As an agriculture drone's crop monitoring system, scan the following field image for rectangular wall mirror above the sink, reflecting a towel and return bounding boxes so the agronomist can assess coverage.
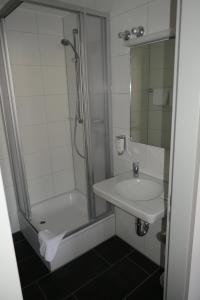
[130,39,175,149]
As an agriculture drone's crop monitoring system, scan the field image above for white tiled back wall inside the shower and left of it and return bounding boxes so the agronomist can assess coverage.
[0,9,79,231]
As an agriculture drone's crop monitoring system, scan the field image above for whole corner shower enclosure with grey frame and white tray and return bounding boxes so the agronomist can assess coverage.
[0,0,114,270]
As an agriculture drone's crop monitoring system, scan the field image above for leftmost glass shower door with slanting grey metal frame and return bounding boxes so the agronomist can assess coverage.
[0,20,31,219]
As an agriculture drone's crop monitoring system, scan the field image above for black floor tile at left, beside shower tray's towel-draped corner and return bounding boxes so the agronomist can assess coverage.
[18,255,49,287]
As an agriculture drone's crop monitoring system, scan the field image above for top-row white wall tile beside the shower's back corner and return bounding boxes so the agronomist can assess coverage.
[37,13,63,36]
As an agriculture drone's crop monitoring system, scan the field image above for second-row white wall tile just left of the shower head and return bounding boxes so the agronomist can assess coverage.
[39,35,65,66]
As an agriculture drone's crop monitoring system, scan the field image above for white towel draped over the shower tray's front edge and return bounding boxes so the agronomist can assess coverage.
[38,229,65,262]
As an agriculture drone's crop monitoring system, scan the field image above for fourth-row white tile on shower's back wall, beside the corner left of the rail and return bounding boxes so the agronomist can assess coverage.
[45,95,69,122]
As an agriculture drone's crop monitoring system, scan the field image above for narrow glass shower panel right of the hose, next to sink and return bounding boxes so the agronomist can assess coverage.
[86,15,109,216]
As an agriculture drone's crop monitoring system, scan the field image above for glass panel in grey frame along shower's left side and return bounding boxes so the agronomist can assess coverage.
[0,21,30,218]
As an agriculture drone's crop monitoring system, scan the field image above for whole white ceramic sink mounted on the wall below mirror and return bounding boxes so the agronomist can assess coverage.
[93,172,165,223]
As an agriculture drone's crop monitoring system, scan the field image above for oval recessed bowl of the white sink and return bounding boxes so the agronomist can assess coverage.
[115,178,163,201]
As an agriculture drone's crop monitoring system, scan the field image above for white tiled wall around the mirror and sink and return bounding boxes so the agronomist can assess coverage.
[111,0,174,263]
